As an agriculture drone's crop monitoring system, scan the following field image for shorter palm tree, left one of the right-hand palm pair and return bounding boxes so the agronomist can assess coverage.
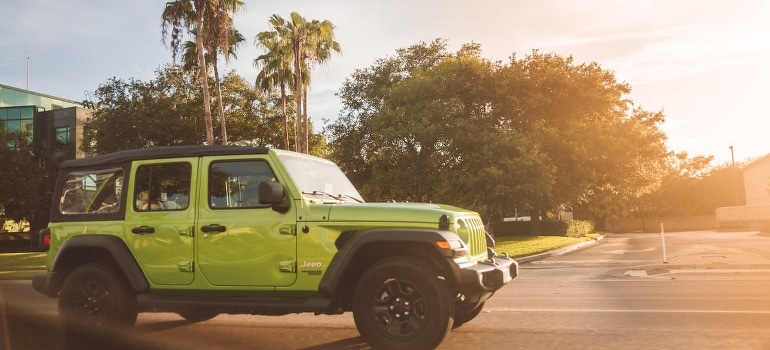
[254,23,297,149]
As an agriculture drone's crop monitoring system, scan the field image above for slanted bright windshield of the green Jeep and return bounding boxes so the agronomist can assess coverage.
[279,154,363,202]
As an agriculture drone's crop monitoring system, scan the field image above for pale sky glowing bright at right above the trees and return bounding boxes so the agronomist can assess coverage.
[0,0,770,165]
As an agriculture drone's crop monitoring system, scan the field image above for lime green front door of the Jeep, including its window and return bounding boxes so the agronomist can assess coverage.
[196,156,297,288]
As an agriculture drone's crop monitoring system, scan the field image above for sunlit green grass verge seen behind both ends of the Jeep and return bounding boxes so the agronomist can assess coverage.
[0,233,601,280]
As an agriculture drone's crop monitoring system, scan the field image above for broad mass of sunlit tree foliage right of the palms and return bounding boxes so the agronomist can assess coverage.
[326,40,666,224]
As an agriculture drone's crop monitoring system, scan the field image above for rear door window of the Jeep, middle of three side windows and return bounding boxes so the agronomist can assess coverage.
[133,163,192,211]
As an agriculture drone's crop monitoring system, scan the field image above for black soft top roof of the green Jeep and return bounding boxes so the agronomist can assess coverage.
[59,145,269,169]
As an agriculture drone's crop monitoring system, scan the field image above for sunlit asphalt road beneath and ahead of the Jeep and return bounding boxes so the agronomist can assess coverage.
[0,232,770,350]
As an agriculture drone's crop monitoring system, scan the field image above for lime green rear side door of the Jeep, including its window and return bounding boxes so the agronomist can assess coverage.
[124,157,198,285]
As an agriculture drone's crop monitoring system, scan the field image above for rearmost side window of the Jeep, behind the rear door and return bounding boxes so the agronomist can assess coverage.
[59,169,123,214]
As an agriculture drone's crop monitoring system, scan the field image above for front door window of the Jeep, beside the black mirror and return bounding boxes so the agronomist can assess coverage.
[208,160,275,209]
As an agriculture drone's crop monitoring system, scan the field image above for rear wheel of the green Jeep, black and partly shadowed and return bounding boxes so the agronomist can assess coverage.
[59,263,137,329]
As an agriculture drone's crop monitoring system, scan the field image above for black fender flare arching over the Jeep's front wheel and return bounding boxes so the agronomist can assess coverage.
[318,228,468,294]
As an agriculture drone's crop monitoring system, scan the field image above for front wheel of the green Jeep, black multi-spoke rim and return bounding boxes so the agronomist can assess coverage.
[352,257,455,349]
